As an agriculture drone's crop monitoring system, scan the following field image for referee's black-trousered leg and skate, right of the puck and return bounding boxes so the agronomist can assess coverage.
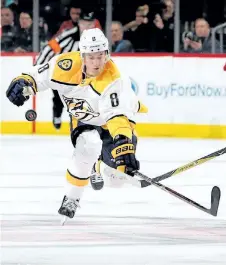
[53,90,64,129]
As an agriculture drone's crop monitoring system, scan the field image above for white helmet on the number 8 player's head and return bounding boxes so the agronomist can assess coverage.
[79,28,109,54]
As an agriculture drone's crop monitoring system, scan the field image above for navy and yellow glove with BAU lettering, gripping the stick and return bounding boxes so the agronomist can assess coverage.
[111,135,140,175]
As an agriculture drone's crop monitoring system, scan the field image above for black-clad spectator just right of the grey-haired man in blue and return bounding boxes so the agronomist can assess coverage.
[124,7,150,52]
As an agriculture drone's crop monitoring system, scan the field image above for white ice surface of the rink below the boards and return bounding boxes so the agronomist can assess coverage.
[0,136,226,265]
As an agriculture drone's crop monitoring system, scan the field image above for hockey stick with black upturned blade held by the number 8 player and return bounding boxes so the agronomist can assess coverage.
[135,172,221,216]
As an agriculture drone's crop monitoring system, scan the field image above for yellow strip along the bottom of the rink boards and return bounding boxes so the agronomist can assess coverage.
[0,121,226,139]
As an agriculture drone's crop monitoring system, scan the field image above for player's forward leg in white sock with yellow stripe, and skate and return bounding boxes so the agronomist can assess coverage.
[58,122,102,218]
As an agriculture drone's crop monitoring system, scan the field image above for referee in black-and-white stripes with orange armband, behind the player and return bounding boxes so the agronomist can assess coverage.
[35,12,98,130]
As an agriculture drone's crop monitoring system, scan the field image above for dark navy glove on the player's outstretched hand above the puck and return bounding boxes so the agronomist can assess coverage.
[6,78,32,107]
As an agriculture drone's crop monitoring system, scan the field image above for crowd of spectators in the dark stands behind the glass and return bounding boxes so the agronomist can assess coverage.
[1,0,220,53]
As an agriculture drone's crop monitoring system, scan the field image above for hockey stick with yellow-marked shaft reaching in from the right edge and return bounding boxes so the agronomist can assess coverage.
[141,144,226,188]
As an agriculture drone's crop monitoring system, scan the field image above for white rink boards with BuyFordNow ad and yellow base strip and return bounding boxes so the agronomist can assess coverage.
[0,54,226,139]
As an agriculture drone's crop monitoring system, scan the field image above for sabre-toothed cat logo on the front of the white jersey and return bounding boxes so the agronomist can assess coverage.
[63,96,100,121]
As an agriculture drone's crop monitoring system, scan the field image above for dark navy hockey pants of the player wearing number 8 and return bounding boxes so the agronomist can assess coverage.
[71,122,137,168]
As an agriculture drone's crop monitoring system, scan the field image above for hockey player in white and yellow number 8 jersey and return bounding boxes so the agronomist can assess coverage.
[6,29,147,221]
